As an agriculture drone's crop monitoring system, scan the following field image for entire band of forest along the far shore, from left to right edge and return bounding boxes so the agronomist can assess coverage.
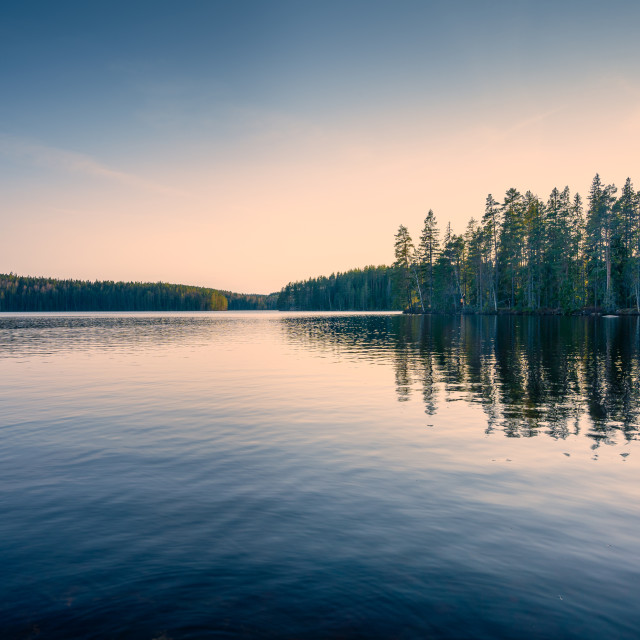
[5,174,640,314]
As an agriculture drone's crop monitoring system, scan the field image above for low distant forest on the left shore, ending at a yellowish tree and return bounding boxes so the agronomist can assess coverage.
[0,273,229,311]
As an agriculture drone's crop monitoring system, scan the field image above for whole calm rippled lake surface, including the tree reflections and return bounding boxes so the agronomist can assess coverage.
[0,312,640,640]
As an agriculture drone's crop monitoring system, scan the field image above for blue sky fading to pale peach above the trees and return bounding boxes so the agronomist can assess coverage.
[0,0,640,293]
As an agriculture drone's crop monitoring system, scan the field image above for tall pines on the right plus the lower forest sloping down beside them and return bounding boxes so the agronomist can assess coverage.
[278,175,640,314]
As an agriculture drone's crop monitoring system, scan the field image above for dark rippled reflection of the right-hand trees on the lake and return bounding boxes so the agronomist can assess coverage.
[285,315,640,448]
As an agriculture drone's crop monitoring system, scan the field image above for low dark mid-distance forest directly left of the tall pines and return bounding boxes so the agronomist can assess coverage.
[277,266,401,311]
